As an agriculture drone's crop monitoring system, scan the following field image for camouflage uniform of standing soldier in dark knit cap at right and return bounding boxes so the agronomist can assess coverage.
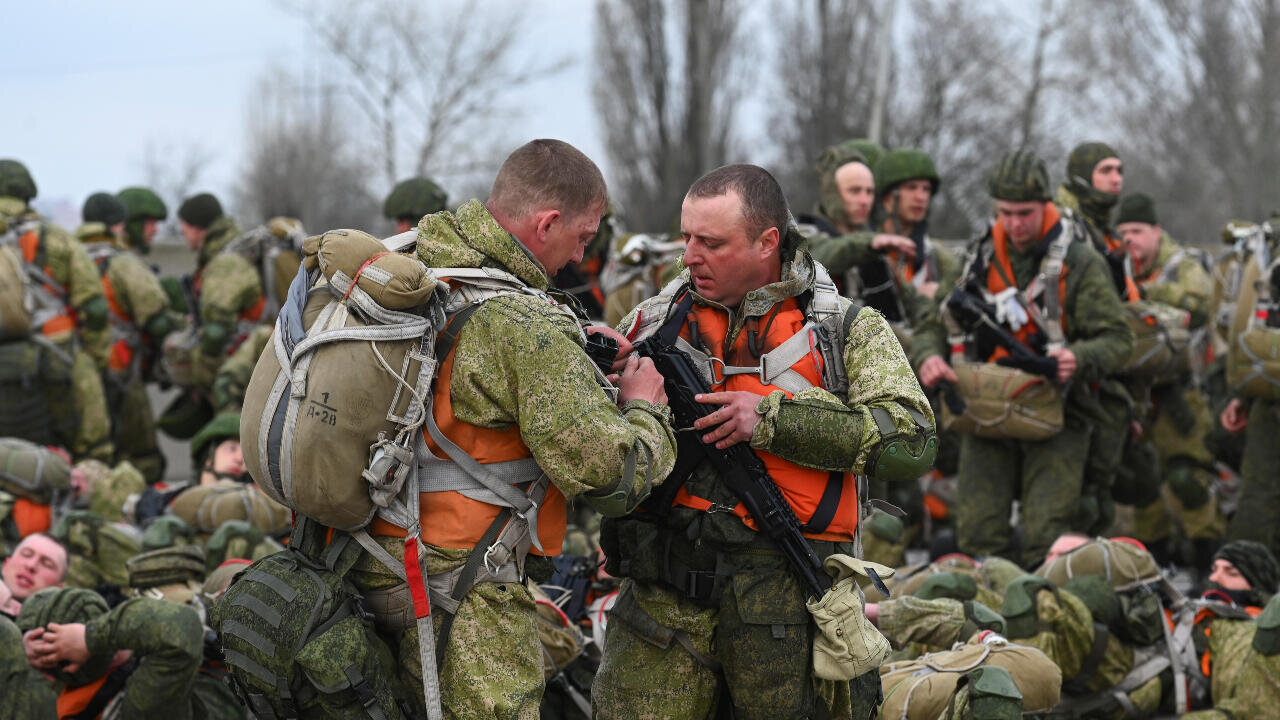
[1125,233,1226,550]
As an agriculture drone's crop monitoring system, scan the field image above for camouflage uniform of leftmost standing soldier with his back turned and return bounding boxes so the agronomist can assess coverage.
[0,192,114,461]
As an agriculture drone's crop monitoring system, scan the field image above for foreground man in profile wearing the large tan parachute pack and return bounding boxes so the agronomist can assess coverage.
[352,140,675,719]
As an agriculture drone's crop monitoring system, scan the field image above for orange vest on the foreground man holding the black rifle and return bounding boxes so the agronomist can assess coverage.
[673,292,858,542]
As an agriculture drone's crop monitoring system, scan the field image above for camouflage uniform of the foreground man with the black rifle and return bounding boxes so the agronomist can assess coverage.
[591,245,933,719]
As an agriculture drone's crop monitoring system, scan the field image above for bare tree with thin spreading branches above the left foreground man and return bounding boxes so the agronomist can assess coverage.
[293,0,567,188]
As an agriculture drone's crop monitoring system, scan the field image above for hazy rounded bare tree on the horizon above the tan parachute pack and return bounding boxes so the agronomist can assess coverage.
[236,70,381,232]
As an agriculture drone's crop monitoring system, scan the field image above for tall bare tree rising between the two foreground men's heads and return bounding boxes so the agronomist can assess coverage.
[593,0,744,229]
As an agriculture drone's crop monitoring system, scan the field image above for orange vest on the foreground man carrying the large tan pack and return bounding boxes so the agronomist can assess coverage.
[369,299,567,557]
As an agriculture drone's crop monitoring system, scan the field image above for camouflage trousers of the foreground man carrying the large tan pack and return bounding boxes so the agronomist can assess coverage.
[351,538,544,720]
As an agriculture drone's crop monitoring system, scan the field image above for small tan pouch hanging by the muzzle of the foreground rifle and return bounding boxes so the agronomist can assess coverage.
[806,555,893,682]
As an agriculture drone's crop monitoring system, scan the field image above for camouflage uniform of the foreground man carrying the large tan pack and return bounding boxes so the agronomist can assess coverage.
[351,200,675,720]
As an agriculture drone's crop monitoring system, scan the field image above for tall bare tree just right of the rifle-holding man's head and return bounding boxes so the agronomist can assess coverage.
[771,0,883,210]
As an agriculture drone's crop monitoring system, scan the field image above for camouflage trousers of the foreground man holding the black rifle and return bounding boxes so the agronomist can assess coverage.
[591,565,878,720]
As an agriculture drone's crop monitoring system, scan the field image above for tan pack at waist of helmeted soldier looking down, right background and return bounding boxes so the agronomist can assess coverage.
[942,363,1064,441]
